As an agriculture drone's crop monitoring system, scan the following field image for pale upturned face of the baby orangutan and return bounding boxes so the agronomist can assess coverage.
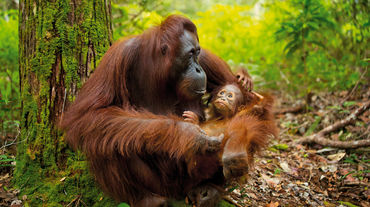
[212,85,243,118]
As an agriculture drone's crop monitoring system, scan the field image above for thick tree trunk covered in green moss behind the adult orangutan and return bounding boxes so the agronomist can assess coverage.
[13,0,112,206]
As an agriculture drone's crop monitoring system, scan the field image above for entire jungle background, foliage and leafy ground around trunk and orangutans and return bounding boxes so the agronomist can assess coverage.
[0,0,370,206]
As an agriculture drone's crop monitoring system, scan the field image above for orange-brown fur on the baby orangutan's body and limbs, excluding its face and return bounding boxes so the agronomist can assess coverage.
[201,90,278,178]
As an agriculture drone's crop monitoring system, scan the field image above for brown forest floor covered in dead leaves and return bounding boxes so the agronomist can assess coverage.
[0,87,370,207]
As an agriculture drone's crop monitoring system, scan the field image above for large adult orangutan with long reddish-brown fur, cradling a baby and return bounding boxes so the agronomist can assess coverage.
[62,15,274,206]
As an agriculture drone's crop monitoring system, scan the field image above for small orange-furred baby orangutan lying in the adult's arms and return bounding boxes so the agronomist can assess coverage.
[183,84,277,207]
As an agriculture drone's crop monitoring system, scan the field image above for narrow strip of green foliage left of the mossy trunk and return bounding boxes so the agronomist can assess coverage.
[0,10,20,135]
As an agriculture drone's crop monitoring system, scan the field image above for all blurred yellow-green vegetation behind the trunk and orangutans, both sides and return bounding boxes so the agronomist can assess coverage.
[0,0,370,136]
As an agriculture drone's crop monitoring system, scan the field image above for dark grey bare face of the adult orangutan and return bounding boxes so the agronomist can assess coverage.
[174,30,207,100]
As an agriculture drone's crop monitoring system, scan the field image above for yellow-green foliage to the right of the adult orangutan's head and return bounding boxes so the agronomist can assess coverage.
[191,0,370,94]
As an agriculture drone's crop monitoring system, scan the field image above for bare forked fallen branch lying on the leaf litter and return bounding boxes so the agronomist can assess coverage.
[295,101,370,149]
